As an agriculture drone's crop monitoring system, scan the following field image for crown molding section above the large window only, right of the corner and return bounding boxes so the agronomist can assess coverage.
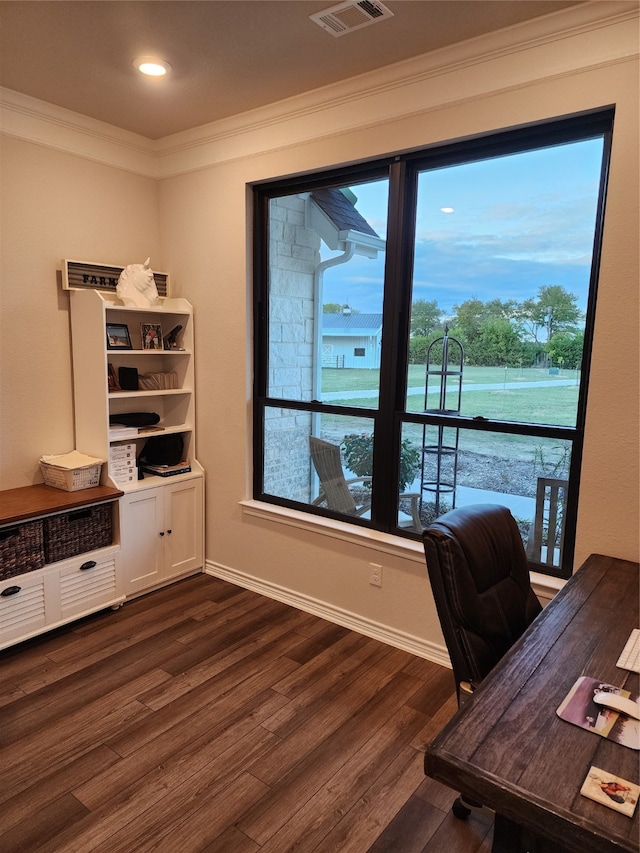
[159,0,639,177]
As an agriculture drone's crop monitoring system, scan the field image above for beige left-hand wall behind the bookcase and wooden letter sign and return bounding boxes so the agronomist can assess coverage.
[0,135,162,489]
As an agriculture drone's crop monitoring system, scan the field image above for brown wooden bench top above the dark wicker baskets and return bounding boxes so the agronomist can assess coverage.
[0,483,124,525]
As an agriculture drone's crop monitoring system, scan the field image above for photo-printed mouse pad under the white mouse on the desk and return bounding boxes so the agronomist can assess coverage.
[556,675,640,750]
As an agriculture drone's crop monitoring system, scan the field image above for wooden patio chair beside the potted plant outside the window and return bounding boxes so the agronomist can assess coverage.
[309,435,422,533]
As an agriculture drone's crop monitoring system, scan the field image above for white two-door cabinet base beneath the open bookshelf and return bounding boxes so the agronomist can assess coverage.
[120,476,204,595]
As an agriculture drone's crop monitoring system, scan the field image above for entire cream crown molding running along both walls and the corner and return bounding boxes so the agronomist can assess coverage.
[0,0,639,178]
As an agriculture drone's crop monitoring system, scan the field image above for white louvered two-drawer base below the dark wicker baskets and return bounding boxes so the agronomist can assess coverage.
[0,545,124,649]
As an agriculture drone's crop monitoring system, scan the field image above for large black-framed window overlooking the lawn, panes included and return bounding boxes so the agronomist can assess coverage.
[254,110,613,577]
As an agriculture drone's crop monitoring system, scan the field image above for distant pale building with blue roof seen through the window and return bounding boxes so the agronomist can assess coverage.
[322,312,382,369]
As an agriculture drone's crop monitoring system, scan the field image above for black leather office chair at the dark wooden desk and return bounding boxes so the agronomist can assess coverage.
[423,504,542,818]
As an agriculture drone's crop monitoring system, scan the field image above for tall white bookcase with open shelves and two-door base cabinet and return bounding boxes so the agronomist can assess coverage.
[70,290,204,595]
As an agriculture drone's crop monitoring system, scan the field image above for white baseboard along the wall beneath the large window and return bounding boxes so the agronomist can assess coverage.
[204,560,451,669]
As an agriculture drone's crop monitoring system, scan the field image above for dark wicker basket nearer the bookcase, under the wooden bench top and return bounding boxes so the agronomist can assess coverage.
[44,503,113,563]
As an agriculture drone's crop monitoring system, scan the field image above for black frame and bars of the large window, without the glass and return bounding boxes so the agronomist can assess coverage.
[253,106,615,578]
